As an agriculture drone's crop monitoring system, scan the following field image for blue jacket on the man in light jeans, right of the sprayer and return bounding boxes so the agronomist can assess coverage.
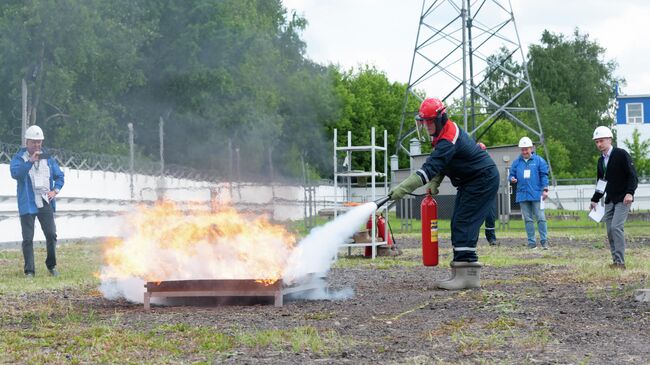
[508,152,548,203]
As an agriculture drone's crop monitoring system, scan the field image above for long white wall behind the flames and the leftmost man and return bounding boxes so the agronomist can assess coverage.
[0,164,344,242]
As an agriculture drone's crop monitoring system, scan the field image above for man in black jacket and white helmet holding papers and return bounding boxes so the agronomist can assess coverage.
[590,126,638,269]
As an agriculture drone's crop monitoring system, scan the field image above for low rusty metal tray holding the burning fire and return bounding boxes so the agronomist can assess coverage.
[144,278,324,310]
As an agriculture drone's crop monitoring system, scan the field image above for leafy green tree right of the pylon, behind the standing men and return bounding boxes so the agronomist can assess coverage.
[528,29,616,177]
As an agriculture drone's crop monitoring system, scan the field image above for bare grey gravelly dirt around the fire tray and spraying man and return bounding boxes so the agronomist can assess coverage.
[3,239,650,364]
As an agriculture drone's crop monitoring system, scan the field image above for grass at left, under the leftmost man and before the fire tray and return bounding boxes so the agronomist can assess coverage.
[0,243,354,364]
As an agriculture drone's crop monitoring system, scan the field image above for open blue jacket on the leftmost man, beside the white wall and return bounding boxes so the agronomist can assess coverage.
[9,147,63,215]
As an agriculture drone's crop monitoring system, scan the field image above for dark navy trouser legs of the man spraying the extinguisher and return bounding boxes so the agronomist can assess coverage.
[451,166,499,262]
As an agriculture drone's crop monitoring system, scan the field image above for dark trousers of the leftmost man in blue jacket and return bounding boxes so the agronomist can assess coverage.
[20,202,56,274]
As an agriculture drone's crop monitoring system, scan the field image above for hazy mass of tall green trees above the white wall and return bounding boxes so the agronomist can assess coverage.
[0,0,340,178]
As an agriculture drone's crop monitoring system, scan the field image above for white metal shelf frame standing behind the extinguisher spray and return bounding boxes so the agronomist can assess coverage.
[334,127,389,259]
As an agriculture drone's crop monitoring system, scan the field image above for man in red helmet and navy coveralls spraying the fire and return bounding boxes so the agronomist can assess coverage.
[389,98,499,290]
